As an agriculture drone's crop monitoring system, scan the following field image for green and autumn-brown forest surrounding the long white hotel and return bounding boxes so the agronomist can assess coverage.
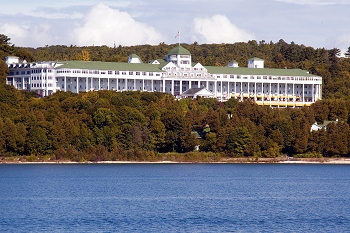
[0,34,350,161]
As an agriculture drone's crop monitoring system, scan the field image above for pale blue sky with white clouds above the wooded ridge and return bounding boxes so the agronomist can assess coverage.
[0,0,350,52]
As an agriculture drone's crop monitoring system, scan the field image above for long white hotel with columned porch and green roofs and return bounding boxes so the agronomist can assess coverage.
[6,45,322,107]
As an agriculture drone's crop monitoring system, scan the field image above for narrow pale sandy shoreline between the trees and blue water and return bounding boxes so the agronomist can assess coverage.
[0,158,350,165]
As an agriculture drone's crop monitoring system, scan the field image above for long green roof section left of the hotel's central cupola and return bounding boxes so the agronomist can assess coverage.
[56,61,162,72]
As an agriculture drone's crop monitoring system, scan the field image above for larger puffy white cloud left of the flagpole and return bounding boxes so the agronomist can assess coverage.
[71,3,164,46]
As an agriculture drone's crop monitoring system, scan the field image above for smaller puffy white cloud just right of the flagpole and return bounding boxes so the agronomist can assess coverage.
[192,15,255,43]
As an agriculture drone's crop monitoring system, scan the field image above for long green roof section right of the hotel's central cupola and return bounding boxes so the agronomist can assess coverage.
[205,66,317,77]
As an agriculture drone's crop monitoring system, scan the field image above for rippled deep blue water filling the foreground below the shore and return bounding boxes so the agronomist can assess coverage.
[0,164,350,232]
